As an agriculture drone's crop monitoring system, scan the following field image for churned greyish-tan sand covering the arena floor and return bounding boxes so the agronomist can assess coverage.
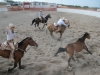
[0,11,100,75]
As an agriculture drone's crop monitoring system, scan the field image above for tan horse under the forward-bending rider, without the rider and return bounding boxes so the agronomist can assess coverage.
[46,20,70,39]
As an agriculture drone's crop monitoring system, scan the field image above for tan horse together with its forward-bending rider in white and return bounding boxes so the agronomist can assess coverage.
[46,17,70,40]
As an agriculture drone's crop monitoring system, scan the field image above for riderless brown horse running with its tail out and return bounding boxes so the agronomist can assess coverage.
[55,32,92,67]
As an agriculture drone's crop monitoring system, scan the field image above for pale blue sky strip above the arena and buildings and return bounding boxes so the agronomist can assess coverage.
[0,0,100,8]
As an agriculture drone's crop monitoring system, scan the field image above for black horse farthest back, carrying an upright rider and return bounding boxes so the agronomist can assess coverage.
[31,14,51,29]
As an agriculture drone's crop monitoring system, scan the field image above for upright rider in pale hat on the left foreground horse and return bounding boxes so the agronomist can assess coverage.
[7,23,16,60]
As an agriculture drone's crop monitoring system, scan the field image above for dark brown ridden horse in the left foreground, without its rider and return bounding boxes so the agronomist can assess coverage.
[0,37,38,72]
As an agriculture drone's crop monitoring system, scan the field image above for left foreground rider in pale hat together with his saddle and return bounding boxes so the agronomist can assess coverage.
[1,23,17,61]
